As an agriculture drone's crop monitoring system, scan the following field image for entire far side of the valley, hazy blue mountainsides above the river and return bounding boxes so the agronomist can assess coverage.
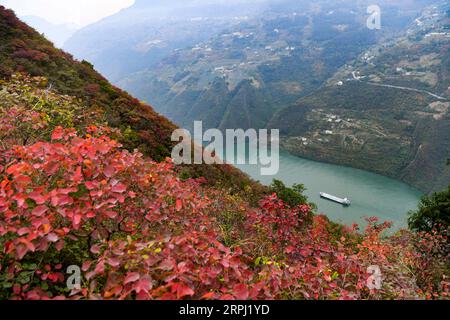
[62,0,450,193]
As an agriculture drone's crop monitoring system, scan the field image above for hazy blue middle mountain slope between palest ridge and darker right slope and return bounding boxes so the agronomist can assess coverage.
[117,1,432,129]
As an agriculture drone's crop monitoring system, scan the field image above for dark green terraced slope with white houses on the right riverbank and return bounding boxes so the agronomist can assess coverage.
[271,83,450,193]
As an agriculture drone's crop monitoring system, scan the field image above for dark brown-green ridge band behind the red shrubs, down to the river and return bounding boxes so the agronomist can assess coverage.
[0,6,263,198]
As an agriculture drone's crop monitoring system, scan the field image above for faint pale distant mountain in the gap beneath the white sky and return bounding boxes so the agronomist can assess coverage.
[20,16,77,48]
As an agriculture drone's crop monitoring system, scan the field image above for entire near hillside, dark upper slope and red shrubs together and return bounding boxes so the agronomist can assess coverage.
[0,8,449,300]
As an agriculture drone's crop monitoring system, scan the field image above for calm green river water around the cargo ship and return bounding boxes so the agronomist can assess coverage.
[236,152,422,230]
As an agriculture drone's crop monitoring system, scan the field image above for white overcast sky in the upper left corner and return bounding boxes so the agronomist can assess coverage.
[0,0,134,27]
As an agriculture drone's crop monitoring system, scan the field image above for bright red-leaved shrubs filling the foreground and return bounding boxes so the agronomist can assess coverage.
[0,119,448,299]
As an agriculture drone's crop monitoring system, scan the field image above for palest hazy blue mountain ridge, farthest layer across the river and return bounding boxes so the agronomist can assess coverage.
[64,0,270,81]
